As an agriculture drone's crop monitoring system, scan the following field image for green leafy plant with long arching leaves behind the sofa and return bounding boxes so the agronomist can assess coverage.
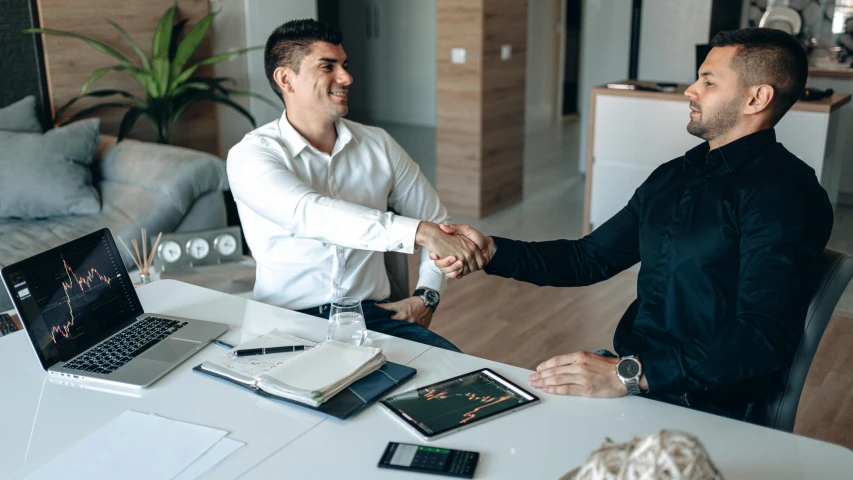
[24,3,277,143]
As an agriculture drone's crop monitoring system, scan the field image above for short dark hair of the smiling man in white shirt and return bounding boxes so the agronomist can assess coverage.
[264,18,343,101]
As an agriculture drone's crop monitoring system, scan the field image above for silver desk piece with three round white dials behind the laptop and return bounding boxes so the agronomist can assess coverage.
[152,226,243,272]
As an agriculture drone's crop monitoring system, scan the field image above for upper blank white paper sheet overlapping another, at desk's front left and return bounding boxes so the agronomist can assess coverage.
[27,411,228,480]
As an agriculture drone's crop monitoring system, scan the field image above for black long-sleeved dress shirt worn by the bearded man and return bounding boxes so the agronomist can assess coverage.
[486,129,833,403]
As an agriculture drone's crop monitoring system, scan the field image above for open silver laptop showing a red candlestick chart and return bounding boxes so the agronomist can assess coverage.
[0,228,228,388]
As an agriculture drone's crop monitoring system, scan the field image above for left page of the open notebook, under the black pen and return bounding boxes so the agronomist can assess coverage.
[201,329,316,385]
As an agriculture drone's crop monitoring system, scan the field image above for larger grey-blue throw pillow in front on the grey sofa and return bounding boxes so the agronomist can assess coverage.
[0,118,101,219]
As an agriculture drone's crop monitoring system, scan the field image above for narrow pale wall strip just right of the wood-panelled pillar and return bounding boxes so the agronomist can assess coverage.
[524,0,562,132]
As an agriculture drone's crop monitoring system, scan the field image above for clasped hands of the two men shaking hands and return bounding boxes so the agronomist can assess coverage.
[415,222,496,278]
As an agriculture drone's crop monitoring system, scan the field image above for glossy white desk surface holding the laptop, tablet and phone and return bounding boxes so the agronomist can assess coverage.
[0,280,853,480]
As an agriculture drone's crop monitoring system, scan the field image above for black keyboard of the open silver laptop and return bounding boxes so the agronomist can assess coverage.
[65,317,187,374]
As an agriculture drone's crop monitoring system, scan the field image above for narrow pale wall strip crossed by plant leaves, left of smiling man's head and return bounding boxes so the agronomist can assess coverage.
[210,0,252,158]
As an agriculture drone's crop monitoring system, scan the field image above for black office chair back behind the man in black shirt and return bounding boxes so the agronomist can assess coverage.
[755,248,853,432]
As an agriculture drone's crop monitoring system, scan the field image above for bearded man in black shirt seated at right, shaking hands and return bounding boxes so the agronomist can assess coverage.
[433,28,833,419]
